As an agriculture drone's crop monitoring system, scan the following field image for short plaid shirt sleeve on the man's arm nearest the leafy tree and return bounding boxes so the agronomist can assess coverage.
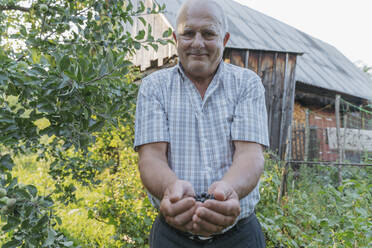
[134,79,169,151]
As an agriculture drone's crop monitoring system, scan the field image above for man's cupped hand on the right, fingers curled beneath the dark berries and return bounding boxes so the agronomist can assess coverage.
[192,181,240,236]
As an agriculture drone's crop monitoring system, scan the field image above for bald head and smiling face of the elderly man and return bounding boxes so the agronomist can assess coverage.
[174,1,229,81]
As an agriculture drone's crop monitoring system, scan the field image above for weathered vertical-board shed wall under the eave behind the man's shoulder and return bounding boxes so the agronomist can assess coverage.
[224,49,297,159]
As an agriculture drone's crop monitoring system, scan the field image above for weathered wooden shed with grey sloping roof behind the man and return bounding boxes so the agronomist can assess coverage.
[129,0,372,158]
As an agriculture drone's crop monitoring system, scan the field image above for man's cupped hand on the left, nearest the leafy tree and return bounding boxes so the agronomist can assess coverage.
[160,180,196,232]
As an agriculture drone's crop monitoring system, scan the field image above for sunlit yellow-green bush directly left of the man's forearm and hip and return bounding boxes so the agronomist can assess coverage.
[89,148,157,247]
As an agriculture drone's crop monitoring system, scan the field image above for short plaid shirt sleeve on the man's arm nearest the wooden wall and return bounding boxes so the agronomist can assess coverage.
[231,76,269,147]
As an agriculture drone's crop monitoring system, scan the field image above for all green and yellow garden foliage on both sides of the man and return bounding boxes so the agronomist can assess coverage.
[0,0,372,248]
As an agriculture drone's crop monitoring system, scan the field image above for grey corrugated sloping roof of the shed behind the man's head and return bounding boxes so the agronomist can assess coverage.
[156,0,372,99]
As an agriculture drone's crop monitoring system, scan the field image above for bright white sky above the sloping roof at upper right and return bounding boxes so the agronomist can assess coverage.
[235,0,372,66]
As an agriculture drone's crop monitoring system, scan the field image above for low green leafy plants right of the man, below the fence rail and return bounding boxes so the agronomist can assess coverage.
[256,157,372,247]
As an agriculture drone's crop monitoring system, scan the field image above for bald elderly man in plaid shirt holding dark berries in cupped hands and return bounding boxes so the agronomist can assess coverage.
[134,0,268,245]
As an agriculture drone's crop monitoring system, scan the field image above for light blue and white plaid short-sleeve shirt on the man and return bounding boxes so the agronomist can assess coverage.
[134,62,269,219]
